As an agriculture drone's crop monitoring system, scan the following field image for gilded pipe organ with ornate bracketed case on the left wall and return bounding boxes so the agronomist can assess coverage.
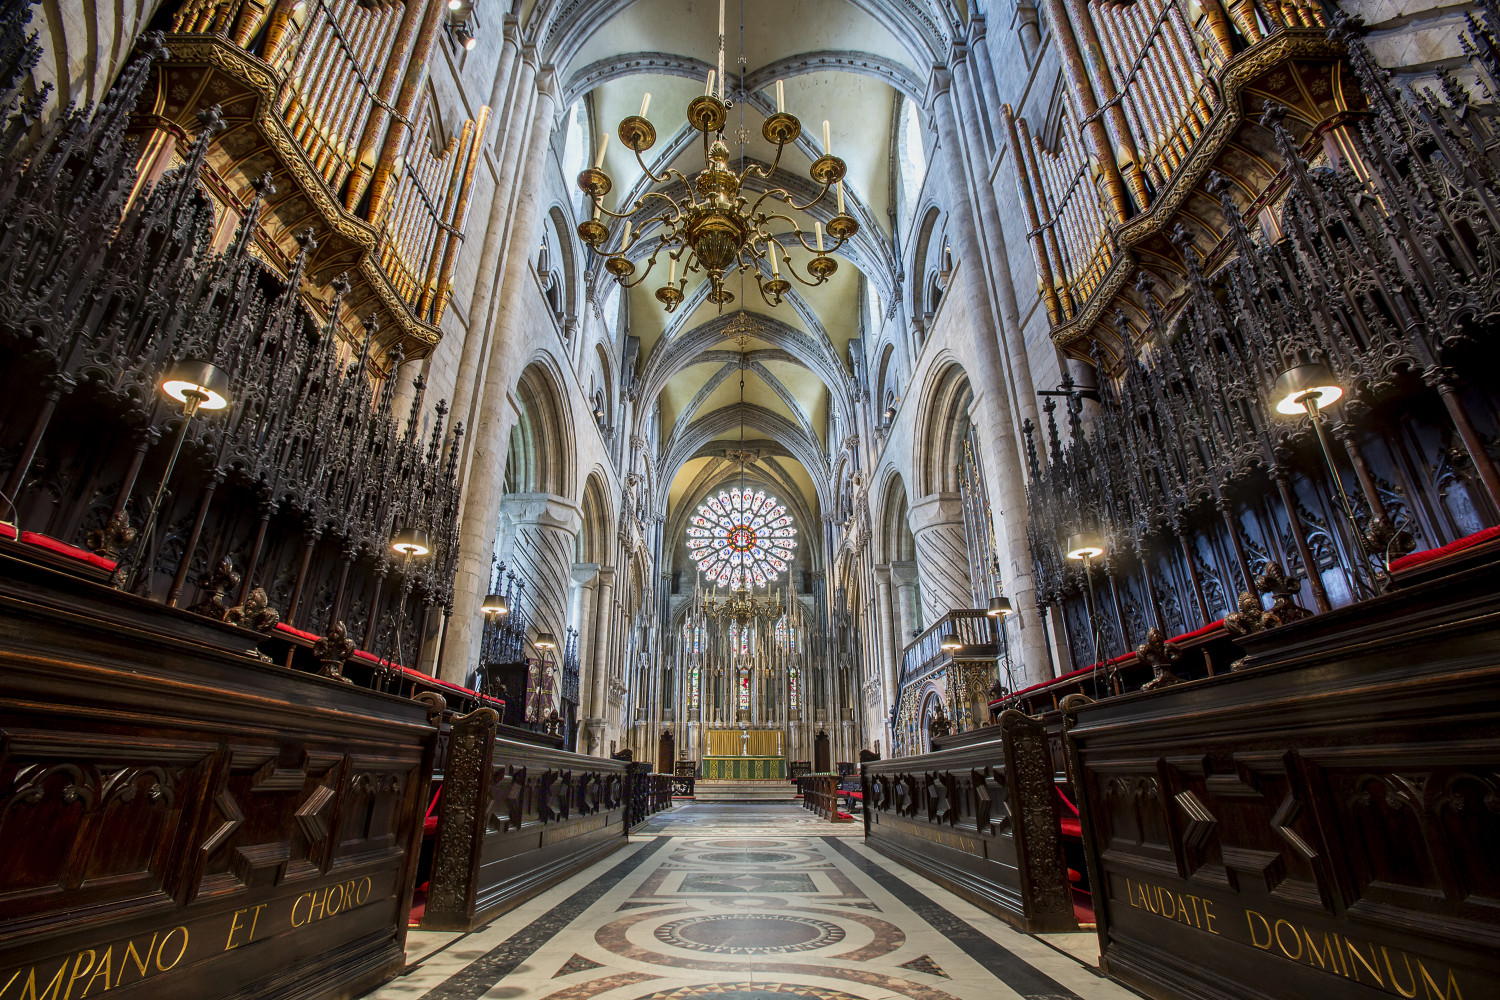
[135,0,489,370]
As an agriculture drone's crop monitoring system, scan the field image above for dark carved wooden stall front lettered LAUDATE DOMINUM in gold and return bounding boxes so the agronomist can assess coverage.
[1065,567,1500,1000]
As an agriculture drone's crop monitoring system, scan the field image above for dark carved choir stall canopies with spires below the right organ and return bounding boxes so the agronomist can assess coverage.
[1026,9,1500,667]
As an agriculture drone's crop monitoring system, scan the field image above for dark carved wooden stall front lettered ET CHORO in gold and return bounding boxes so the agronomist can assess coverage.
[0,549,437,1000]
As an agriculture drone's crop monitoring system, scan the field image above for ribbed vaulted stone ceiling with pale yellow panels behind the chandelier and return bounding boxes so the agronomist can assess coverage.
[546,0,938,569]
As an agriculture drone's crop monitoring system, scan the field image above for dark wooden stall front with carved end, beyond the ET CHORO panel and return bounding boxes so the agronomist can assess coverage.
[422,708,630,930]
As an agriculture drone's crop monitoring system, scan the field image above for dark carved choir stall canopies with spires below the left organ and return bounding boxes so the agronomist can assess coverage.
[0,21,462,663]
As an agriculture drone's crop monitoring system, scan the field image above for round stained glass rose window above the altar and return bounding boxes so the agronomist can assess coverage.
[687,489,797,589]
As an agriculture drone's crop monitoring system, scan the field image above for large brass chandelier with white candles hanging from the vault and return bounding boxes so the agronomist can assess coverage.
[578,0,860,312]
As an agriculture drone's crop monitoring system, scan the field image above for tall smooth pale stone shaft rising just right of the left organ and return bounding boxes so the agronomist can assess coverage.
[441,70,558,684]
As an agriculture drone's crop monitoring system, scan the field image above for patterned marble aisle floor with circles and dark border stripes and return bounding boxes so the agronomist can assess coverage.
[368,804,1137,1000]
